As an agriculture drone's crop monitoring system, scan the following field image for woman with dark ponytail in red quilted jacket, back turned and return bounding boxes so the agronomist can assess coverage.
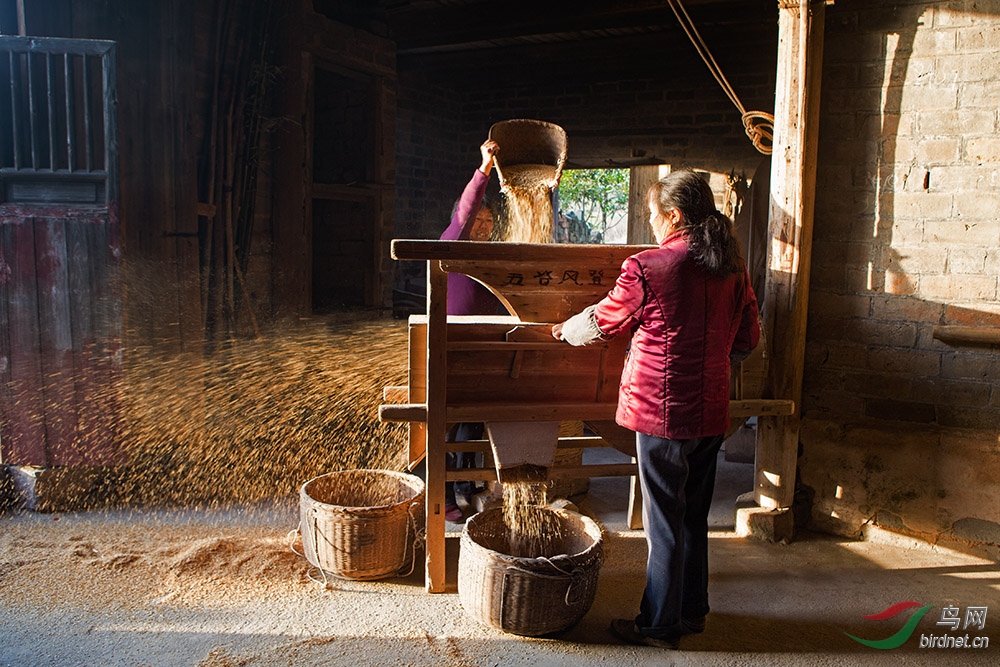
[552,170,760,648]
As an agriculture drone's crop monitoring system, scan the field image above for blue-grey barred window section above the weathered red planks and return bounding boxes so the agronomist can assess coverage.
[0,36,117,205]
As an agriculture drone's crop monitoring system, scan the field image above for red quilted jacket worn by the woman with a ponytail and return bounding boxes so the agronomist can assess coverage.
[594,232,760,439]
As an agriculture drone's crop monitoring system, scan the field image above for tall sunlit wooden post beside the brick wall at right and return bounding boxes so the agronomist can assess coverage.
[754,0,827,508]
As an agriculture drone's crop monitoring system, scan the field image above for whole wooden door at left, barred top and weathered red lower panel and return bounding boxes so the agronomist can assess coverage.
[0,37,122,466]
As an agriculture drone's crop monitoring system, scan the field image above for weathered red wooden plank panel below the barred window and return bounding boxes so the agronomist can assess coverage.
[0,205,122,466]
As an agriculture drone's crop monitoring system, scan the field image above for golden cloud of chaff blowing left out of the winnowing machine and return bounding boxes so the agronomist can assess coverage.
[8,319,407,508]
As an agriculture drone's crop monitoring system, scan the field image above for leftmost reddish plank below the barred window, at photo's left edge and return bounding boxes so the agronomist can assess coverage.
[0,218,48,466]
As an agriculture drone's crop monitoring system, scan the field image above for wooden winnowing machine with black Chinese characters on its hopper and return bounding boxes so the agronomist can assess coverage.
[379,240,793,592]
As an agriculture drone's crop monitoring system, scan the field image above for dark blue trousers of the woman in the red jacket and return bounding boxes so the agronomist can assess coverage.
[635,433,724,640]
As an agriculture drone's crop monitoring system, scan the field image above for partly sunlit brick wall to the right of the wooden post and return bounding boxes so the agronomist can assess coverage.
[802,0,1000,552]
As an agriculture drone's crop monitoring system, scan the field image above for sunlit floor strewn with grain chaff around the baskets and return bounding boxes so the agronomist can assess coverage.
[0,448,1000,667]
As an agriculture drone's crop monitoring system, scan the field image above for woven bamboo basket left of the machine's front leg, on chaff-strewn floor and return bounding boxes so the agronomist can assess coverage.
[299,469,424,580]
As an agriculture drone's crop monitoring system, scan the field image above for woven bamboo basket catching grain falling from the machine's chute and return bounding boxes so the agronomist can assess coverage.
[458,508,604,637]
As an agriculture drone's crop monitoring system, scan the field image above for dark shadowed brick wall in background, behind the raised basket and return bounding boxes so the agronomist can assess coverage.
[395,16,777,294]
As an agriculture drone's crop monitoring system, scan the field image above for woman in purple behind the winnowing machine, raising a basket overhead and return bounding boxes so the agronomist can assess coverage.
[441,139,501,522]
